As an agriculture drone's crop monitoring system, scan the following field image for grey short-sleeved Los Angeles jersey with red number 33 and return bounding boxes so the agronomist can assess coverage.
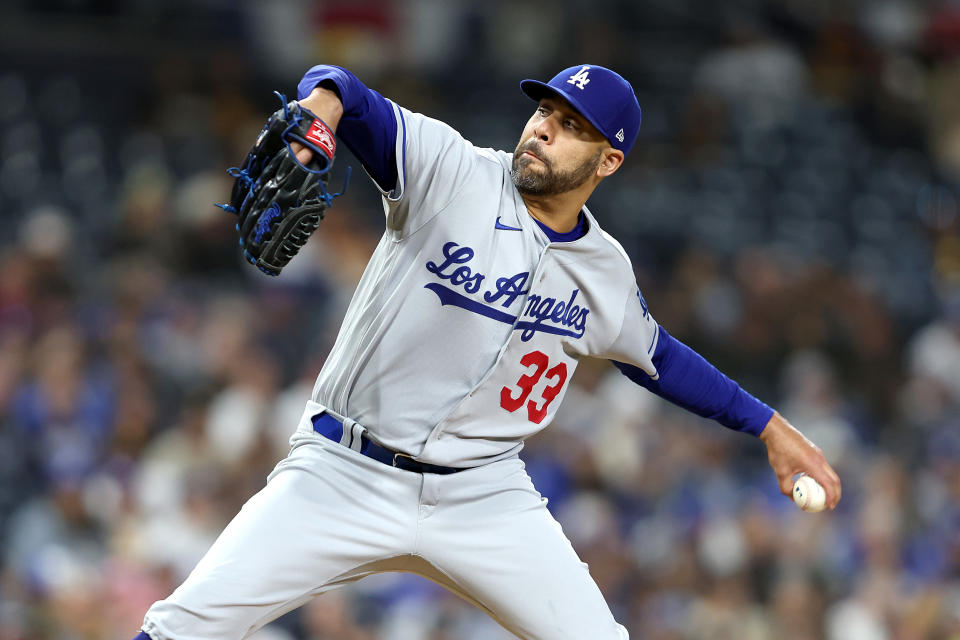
[313,105,658,467]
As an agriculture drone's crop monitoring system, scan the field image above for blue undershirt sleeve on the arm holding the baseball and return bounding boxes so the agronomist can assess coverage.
[612,327,773,436]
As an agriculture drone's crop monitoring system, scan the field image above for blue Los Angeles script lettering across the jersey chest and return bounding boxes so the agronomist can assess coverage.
[426,242,590,340]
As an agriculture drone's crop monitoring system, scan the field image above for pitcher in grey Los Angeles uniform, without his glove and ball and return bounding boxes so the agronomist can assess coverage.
[129,64,840,640]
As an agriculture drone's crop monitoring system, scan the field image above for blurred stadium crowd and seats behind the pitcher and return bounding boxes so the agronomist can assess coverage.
[0,0,960,640]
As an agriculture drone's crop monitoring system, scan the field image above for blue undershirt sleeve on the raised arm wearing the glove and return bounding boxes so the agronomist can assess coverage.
[297,64,397,192]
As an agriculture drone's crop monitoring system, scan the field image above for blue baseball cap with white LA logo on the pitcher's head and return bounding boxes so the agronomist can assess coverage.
[520,64,640,155]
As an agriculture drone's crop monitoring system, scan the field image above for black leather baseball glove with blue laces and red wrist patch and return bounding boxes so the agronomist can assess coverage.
[217,92,350,276]
